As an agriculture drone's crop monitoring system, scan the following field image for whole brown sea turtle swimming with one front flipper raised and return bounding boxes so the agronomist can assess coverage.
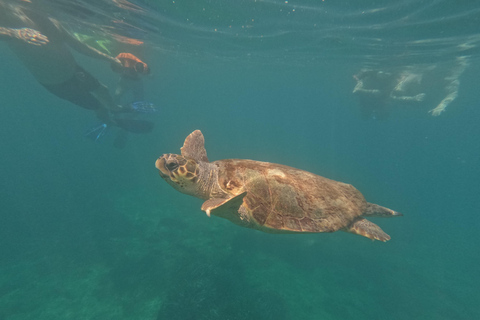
[155,130,402,241]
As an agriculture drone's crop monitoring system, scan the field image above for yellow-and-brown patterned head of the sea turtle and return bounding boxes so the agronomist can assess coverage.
[155,153,200,197]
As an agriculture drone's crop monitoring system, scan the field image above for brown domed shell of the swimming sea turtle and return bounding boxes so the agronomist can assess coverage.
[213,159,367,232]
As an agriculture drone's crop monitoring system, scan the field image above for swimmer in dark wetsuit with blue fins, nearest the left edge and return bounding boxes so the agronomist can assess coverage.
[0,0,153,138]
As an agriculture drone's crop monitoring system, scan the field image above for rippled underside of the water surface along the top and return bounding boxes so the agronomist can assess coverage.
[9,0,480,63]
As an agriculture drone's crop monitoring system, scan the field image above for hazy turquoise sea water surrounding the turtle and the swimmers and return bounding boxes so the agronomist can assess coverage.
[0,1,480,320]
